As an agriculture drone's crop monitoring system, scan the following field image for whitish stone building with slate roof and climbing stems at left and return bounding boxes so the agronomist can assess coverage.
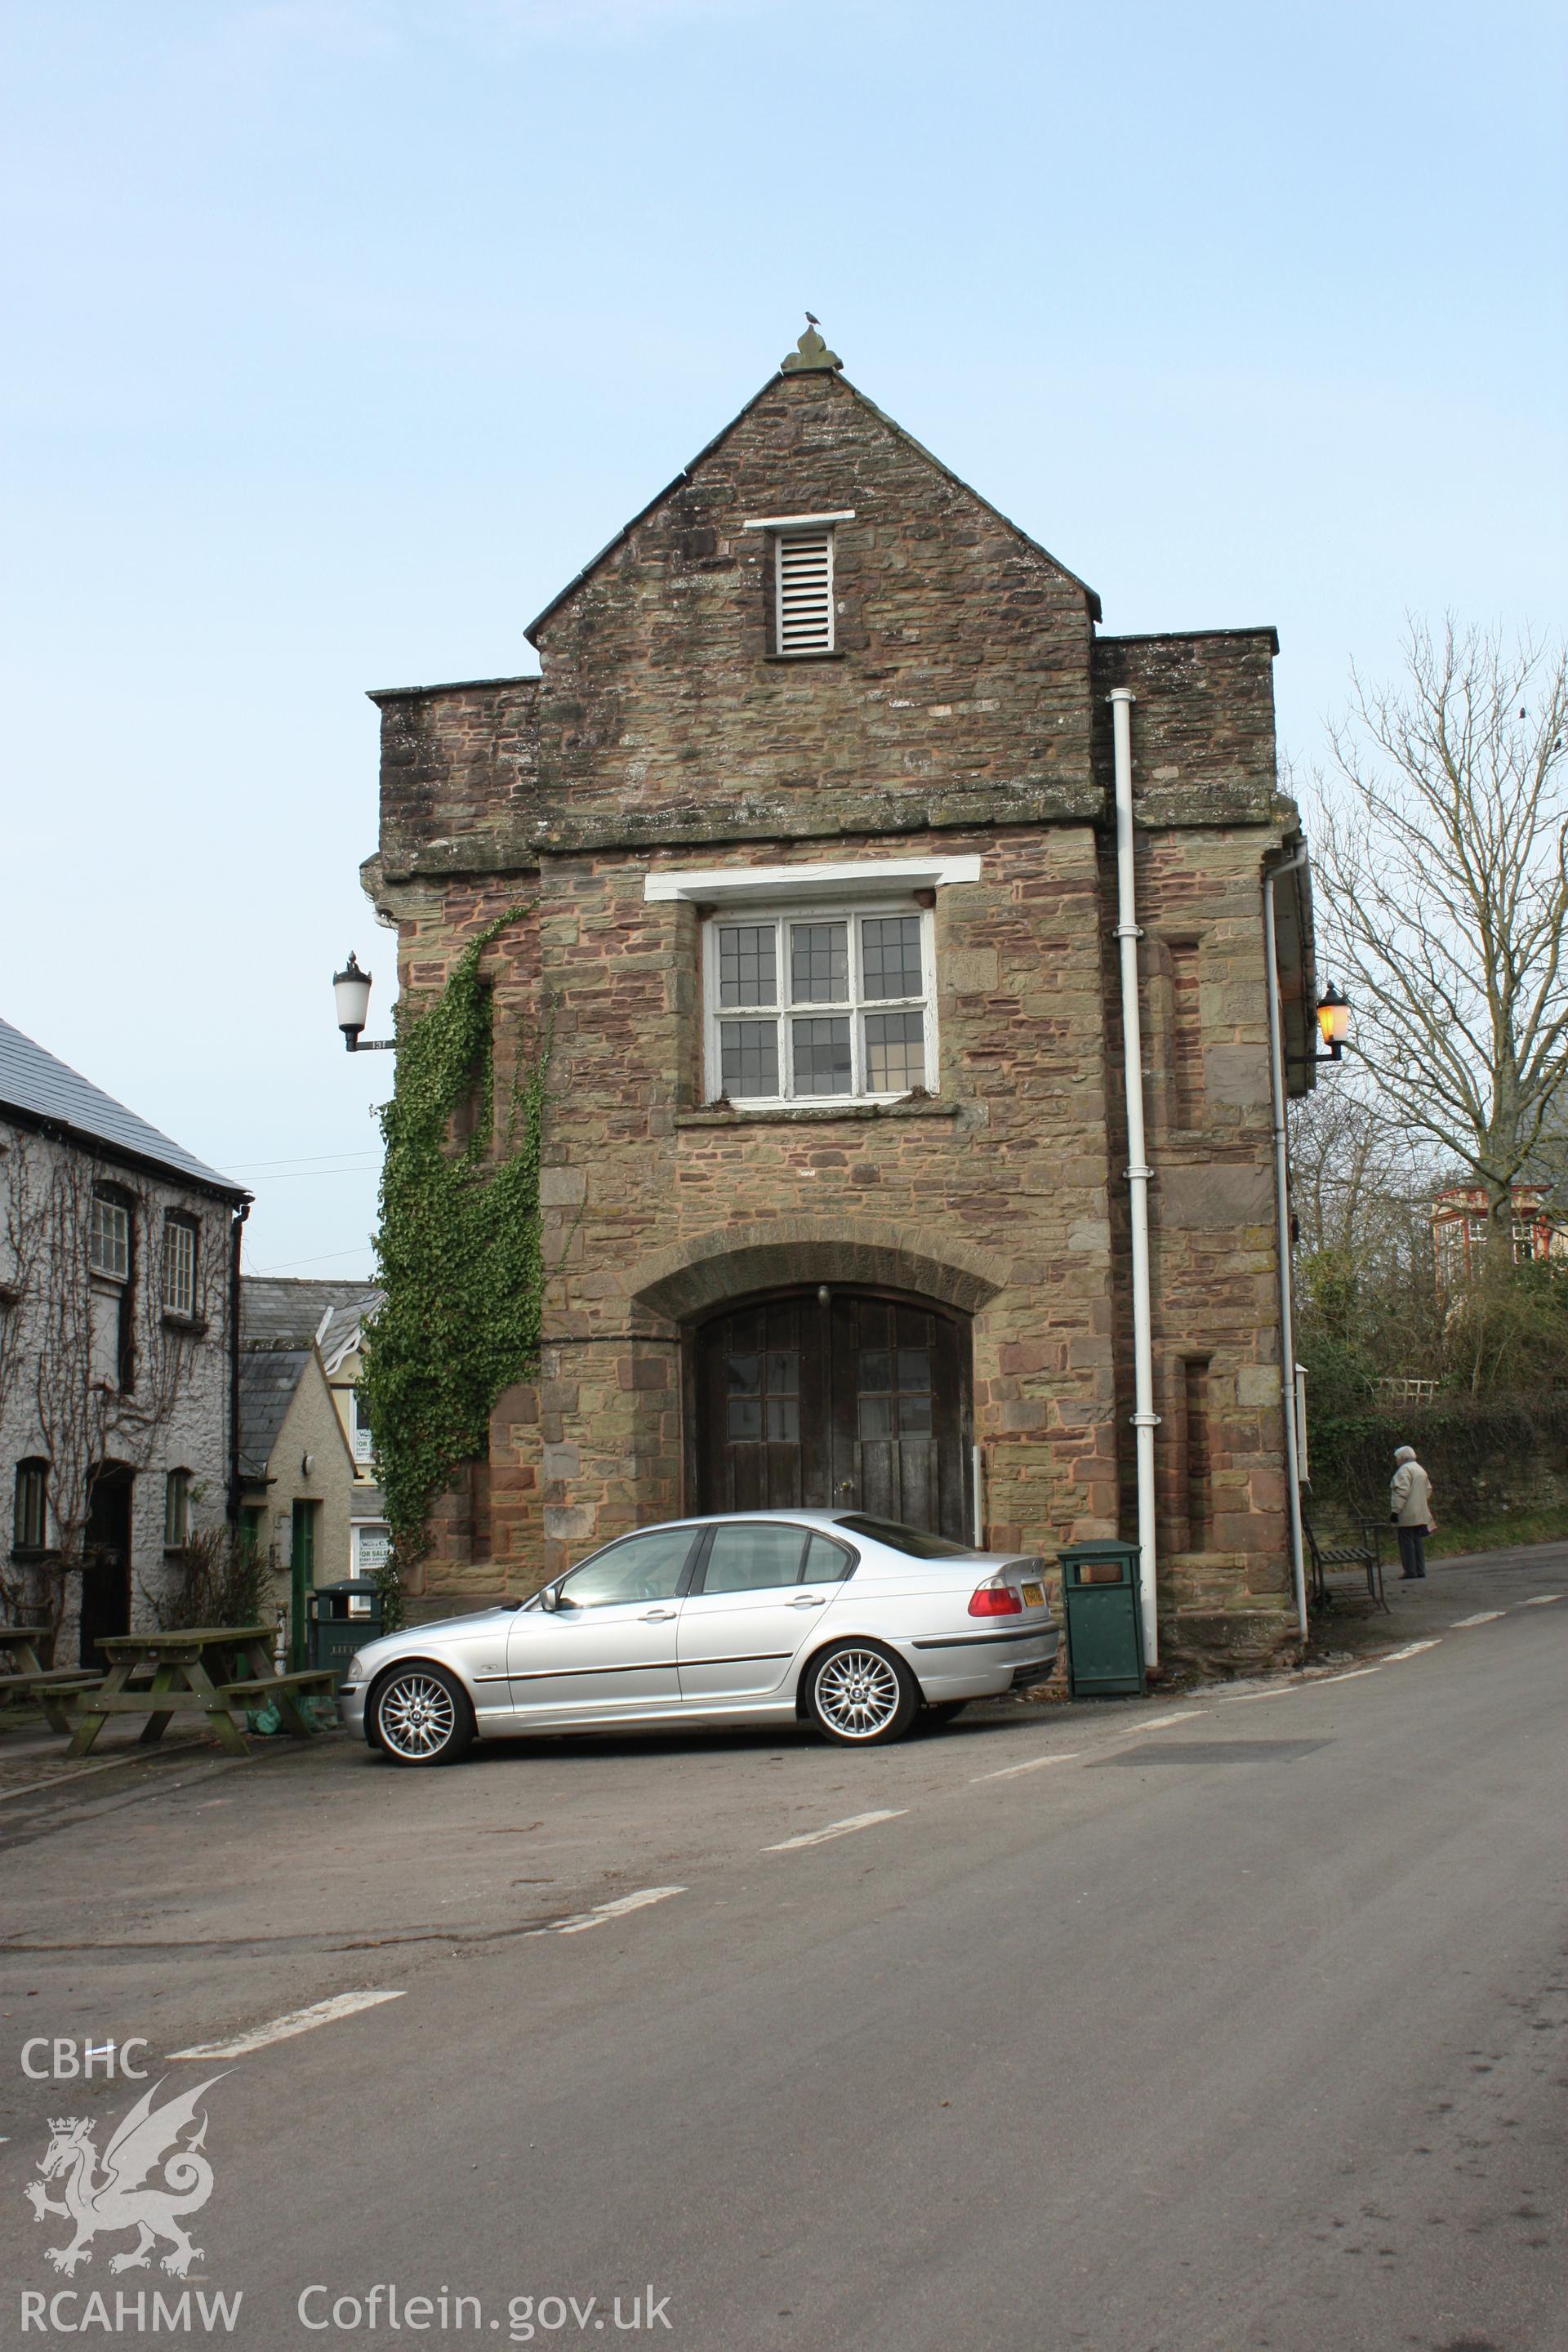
[0,1021,249,1663]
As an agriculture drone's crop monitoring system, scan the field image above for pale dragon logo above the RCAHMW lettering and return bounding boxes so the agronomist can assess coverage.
[24,2074,223,2279]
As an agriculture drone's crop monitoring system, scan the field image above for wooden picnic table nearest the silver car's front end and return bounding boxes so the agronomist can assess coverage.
[70,1625,339,1757]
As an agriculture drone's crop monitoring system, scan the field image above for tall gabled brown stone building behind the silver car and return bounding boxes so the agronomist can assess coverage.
[364,334,1314,1656]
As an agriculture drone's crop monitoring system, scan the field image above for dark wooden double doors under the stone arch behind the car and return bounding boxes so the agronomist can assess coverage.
[688,1289,971,1543]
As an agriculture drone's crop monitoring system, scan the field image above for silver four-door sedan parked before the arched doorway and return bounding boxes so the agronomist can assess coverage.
[339,1510,1060,1764]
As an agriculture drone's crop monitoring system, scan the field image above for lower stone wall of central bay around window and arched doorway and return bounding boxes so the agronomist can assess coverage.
[526,828,1114,1569]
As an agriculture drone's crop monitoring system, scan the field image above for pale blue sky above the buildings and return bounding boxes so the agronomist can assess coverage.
[0,0,1568,1275]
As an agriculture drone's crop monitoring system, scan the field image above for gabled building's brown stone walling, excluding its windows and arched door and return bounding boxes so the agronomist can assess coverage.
[367,353,1300,1658]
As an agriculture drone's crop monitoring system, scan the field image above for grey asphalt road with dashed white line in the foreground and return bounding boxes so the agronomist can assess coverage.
[0,1566,1568,2352]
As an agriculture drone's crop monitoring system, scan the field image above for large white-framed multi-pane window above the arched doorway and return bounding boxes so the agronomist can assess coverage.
[703,898,938,1103]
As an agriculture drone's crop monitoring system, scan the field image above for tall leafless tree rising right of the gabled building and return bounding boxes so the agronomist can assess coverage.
[1316,621,1568,1245]
